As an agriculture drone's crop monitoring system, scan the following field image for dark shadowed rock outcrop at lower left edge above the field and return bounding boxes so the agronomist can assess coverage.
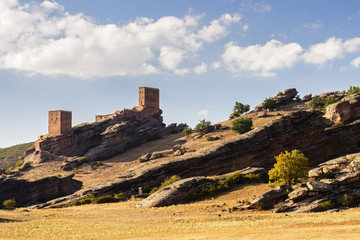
[0,174,82,206]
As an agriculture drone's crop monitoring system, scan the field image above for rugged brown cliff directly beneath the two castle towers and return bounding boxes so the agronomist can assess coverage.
[25,107,185,165]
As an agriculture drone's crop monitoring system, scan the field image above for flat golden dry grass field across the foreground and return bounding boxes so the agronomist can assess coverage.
[0,184,360,240]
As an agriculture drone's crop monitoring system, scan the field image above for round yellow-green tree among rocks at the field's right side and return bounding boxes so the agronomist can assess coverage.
[269,149,309,186]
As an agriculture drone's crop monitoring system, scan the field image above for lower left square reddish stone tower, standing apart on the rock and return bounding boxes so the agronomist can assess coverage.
[49,110,72,135]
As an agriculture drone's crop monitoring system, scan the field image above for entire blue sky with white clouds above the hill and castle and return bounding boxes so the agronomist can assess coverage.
[0,0,360,147]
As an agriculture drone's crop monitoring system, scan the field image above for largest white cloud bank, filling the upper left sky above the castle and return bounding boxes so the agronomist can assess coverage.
[0,0,241,78]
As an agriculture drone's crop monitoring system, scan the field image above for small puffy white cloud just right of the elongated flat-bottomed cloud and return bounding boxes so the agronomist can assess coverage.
[303,37,343,66]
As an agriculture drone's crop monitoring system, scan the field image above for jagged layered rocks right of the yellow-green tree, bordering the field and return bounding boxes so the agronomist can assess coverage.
[245,153,360,212]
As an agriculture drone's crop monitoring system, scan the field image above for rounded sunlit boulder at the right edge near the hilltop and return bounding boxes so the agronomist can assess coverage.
[325,93,360,123]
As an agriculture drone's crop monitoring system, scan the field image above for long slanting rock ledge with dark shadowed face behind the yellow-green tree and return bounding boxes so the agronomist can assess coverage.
[31,111,360,207]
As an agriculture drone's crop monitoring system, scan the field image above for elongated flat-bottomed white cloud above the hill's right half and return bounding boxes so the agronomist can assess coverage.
[222,40,303,77]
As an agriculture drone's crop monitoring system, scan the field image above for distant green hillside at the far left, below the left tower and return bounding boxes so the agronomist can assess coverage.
[0,142,34,169]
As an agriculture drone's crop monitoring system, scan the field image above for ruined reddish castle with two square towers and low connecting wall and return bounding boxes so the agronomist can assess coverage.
[48,87,159,136]
